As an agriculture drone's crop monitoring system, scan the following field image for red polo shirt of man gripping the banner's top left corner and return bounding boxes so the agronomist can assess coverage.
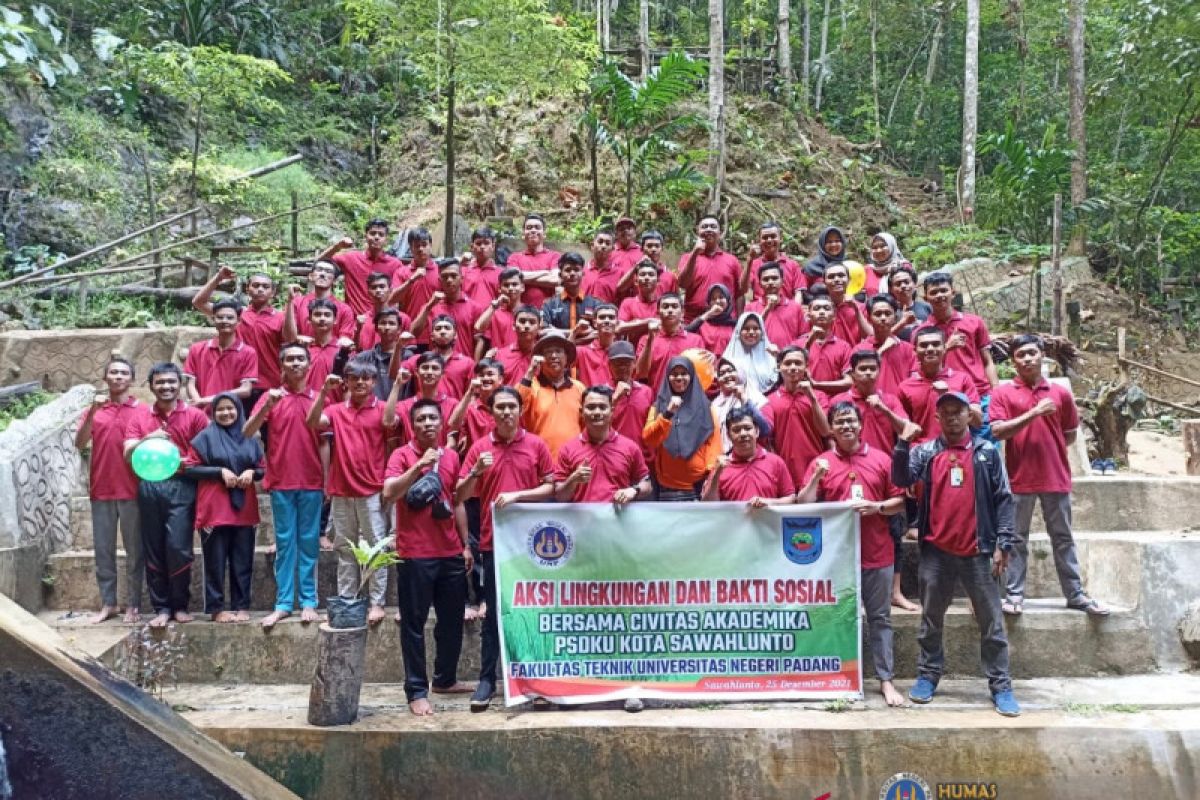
[458,429,554,553]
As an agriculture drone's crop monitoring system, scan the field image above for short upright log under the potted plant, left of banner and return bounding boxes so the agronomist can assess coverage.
[308,622,367,726]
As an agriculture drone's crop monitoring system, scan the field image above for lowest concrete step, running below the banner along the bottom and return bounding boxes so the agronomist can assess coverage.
[174,676,1200,800]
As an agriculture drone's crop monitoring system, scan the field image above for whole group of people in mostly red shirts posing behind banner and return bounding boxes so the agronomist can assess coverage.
[77,213,1108,715]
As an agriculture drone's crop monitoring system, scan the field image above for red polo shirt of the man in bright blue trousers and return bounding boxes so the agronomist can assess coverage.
[251,389,325,492]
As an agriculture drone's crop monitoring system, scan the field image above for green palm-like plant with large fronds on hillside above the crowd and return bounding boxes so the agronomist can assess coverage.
[584,52,708,213]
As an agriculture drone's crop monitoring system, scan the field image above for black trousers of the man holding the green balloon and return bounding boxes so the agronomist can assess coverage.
[138,477,196,614]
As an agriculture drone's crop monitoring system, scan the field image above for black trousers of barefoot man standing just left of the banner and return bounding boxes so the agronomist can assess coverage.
[398,555,467,703]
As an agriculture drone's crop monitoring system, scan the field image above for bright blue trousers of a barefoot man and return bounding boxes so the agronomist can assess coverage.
[271,489,323,612]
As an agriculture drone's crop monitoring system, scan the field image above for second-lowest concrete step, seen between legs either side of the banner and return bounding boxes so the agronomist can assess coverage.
[43,600,1158,684]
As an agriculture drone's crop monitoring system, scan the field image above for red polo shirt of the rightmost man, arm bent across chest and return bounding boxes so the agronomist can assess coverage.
[989,378,1079,494]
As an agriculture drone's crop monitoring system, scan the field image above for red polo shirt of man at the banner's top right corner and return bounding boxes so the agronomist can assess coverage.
[804,443,904,570]
